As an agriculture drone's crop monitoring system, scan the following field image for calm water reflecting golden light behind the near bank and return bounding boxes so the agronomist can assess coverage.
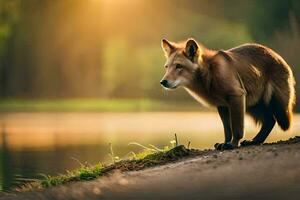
[0,112,300,190]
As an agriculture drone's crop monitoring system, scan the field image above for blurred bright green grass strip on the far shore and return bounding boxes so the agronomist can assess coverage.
[0,98,199,112]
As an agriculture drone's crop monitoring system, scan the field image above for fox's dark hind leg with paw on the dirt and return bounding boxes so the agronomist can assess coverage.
[241,103,276,146]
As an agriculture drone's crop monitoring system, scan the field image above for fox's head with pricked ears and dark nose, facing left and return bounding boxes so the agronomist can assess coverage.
[160,39,201,89]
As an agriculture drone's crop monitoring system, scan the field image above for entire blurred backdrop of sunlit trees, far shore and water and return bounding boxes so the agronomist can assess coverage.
[0,0,300,190]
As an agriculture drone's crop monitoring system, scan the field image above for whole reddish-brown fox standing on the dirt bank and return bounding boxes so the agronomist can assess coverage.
[160,38,296,150]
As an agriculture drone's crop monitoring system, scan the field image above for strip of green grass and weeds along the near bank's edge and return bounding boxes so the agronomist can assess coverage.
[16,136,198,191]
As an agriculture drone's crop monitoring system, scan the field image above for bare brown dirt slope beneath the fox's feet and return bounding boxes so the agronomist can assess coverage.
[0,137,300,200]
